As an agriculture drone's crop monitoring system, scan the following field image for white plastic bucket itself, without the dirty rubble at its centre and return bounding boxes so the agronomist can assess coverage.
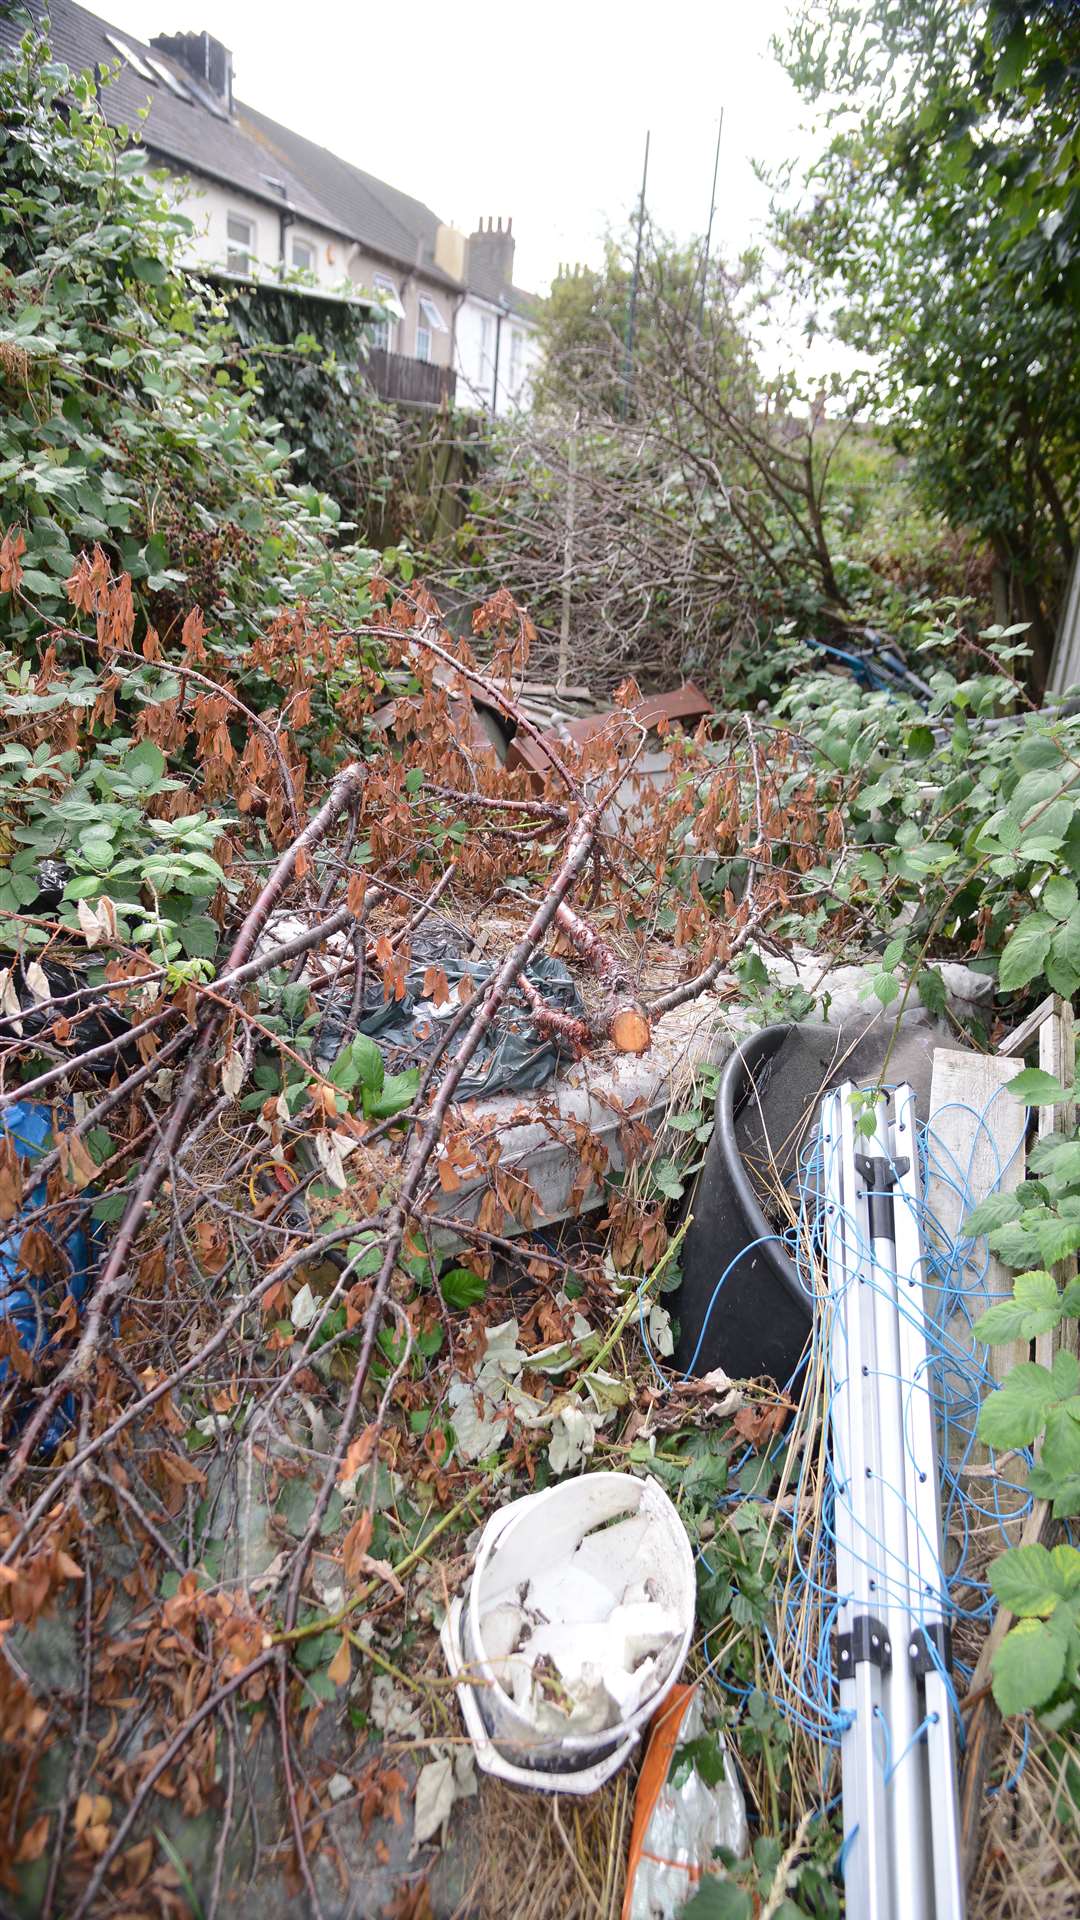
[442,1473,696,1793]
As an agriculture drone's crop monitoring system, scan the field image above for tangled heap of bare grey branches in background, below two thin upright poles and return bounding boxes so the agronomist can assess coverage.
[432,225,849,691]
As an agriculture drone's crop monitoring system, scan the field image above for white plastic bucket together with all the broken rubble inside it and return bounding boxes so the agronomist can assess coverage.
[442,1473,694,1793]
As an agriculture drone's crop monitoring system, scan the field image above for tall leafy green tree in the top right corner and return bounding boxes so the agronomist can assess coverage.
[776,0,1080,685]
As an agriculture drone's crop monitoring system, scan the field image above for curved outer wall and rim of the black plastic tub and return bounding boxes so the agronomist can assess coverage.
[675,1025,811,1386]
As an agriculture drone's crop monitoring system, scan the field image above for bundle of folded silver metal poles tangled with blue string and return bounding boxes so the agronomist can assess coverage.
[821,1085,963,1920]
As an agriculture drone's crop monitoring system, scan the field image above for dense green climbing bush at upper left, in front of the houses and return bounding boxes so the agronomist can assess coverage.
[0,24,373,637]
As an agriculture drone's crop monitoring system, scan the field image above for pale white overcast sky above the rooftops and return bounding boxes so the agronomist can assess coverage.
[92,0,805,292]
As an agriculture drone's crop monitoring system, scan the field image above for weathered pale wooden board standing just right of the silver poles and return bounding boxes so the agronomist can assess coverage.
[926,1046,1028,1482]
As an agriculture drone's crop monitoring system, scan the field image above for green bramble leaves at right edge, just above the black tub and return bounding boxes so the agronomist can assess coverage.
[764,603,1080,1006]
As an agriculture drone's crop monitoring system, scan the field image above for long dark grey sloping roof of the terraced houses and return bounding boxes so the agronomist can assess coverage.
[0,0,532,319]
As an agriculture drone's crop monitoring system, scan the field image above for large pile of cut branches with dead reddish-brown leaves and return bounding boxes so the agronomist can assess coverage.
[0,536,795,1920]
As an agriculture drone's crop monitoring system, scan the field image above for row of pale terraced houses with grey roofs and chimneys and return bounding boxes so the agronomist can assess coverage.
[0,0,540,415]
